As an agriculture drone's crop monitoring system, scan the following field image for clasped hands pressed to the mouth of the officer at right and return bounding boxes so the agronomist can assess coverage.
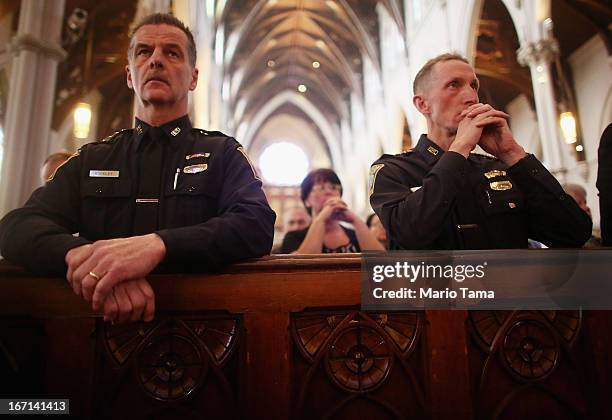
[449,103,526,166]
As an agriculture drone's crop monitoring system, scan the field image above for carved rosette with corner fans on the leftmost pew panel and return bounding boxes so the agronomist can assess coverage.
[103,316,239,401]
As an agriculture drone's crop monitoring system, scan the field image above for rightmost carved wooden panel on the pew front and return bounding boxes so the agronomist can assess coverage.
[468,311,592,419]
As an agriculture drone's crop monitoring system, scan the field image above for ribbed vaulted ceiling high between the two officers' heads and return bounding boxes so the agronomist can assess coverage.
[215,0,404,161]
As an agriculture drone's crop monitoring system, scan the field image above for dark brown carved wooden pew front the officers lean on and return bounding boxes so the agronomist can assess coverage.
[0,254,612,419]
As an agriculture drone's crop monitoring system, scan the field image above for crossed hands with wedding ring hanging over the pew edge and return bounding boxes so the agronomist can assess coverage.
[65,233,166,322]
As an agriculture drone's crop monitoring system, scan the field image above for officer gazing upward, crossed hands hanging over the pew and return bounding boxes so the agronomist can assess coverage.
[0,14,275,321]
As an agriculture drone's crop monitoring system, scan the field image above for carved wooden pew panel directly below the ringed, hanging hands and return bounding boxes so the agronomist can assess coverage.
[94,314,244,419]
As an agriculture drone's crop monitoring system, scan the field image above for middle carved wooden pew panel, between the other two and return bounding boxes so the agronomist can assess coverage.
[290,311,425,419]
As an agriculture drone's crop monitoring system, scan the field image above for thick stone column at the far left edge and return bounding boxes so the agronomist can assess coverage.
[0,0,66,216]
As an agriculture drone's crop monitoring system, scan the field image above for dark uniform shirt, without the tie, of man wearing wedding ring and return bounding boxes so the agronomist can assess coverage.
[0,116,276,275]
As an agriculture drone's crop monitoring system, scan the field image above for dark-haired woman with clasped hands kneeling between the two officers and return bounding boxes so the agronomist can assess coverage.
[281,169,384,254]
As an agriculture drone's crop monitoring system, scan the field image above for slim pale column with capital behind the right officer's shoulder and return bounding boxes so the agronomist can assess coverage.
[517,38,574,179]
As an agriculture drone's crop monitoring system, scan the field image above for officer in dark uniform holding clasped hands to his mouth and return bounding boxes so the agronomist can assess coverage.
[370,54,592,249]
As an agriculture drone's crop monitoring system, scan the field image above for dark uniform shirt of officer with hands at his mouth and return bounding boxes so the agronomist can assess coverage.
[370,135,592,250]
